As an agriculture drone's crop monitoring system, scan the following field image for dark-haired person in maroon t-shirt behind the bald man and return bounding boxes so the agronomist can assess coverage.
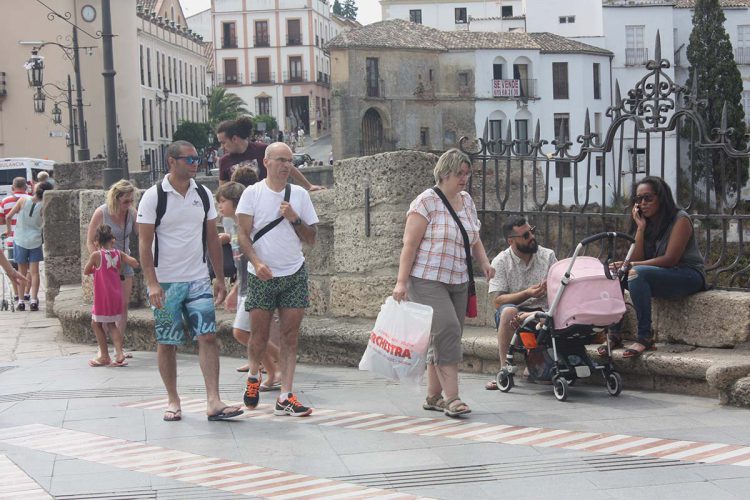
[216,116,325,191]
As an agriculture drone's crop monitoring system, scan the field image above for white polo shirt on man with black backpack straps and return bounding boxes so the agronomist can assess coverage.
[136,176,217,283]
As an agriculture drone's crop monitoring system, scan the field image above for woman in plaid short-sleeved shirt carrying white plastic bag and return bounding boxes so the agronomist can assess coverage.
[393,149,494,417]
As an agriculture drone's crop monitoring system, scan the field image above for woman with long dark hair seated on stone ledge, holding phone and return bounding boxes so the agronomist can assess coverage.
[598,176,706,358]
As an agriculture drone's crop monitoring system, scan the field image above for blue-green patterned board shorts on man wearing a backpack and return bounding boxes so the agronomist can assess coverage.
[151,278,216,345]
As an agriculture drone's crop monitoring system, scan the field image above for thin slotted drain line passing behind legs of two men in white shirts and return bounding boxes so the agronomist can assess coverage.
[0,378,396,403]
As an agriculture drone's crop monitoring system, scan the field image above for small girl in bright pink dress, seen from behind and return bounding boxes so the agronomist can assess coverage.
[83,224,138,367]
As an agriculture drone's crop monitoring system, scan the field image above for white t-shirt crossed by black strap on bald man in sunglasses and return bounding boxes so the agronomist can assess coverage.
[237,179,318,278]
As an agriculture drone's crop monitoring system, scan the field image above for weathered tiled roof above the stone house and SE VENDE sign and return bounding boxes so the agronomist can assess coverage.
[328,19,611,55]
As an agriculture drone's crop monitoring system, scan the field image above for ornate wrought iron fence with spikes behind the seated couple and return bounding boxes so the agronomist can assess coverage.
[459,34,750,291]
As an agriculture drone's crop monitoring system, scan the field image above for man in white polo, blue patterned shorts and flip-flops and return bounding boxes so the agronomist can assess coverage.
[137,141,242,422]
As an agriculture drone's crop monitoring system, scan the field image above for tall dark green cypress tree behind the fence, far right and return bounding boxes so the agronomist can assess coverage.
[687,0,748,209]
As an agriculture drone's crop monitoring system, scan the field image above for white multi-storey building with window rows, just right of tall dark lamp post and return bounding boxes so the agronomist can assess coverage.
[137,0,211,171]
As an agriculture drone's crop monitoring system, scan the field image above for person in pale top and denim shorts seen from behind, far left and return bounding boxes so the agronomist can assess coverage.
[5,182,52,311]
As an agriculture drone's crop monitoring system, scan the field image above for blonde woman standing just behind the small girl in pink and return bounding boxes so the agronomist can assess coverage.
[86,179,138,357]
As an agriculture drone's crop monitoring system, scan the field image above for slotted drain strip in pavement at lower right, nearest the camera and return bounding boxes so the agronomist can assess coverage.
[334,455,693,489]
